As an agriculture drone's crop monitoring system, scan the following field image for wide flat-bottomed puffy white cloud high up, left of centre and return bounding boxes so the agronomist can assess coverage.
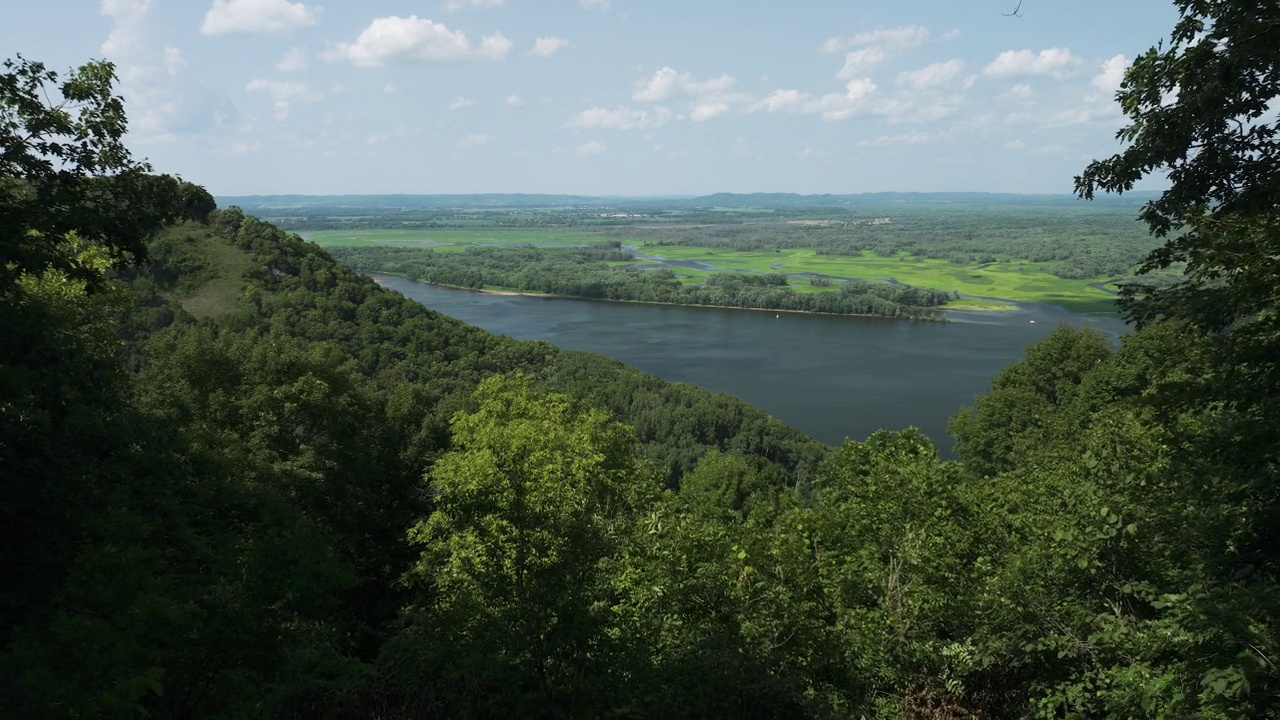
[325,15,512,67]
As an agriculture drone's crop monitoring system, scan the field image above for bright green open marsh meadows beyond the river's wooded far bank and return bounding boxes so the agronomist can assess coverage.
[301,228,1115,313]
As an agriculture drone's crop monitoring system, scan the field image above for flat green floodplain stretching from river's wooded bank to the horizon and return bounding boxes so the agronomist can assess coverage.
[224,193,1158,316]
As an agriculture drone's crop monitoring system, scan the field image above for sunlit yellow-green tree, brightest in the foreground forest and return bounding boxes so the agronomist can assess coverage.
[393,374,657,716]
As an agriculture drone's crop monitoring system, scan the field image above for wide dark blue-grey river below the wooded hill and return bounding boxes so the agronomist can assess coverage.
[369,273,1125,455]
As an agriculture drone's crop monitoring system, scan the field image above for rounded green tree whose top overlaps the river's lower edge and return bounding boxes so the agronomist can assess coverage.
[804,429,978,716]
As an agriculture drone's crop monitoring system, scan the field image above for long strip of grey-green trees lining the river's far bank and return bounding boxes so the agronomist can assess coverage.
[329,242,951,319]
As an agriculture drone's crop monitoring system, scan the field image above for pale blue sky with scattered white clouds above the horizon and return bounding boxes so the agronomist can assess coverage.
[0,0,1176,196]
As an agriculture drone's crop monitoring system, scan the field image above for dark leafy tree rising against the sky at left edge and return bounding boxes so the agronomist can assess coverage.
[0,55,194,292]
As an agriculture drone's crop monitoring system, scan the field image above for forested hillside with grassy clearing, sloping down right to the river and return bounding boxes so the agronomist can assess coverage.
[136,208,824,484]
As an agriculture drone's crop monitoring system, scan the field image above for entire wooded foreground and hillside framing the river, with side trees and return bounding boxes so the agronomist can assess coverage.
[0,0,1280,719]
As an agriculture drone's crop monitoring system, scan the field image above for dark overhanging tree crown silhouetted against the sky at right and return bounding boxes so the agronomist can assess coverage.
[1075,0,1280,333]
